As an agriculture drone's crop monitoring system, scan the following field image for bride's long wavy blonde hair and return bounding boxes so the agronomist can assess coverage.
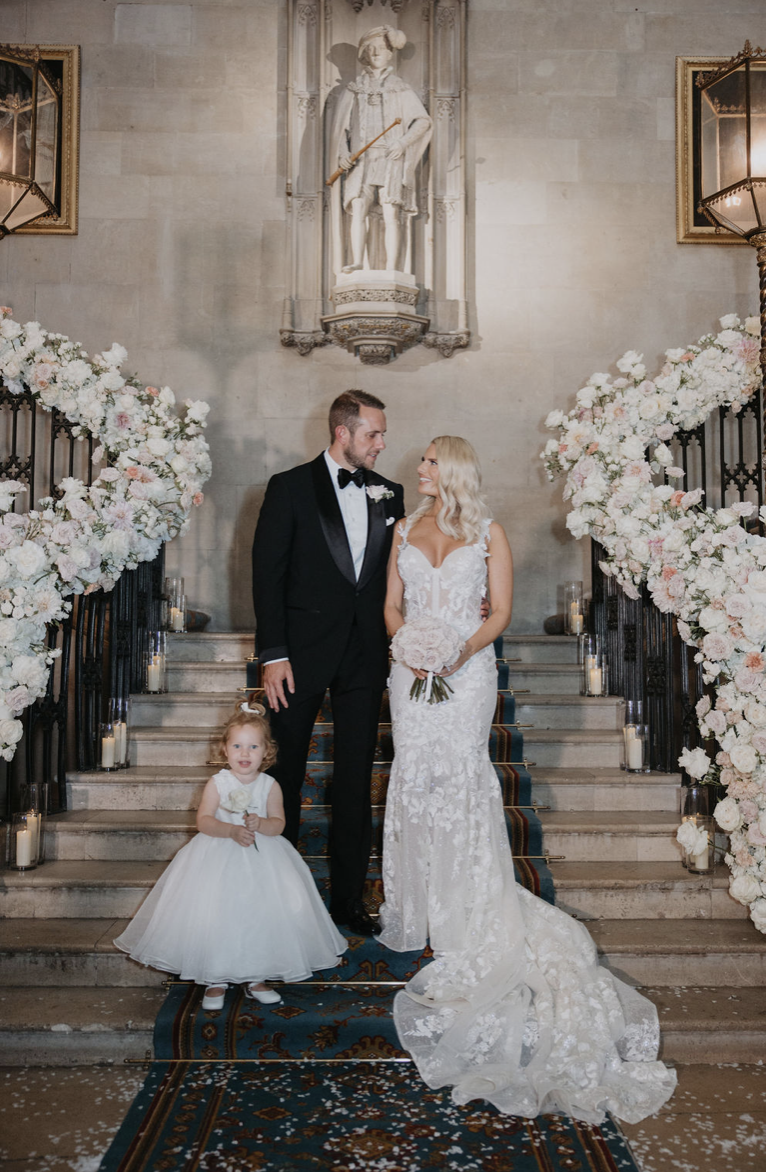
[411,436,490,545]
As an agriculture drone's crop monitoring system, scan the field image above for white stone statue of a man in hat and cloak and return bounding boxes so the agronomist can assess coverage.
[329,25,432,273]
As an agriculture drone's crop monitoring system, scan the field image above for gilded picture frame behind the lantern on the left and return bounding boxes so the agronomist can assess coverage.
[16,45,80,236]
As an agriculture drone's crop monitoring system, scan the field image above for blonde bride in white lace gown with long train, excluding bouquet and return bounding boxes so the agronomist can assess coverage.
[379,436,676,1123]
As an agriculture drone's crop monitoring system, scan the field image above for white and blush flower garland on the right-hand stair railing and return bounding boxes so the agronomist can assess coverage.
[542,314,766,932]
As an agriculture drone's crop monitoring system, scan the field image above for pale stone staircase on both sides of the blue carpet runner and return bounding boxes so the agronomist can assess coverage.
[0,633,766,1064]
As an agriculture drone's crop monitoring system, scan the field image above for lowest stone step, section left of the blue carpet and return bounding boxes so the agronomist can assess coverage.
[0,987,166,1067]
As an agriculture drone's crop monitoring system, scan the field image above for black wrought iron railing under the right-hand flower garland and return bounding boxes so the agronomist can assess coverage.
[589,393,764,772]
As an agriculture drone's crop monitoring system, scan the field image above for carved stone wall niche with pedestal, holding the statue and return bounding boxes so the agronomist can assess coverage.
[280,0,471,366]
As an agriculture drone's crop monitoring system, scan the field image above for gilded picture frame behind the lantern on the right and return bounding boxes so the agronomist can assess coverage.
[676,57,747,244]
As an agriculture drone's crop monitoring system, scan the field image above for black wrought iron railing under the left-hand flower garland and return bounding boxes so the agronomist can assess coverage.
[0,381,164,815]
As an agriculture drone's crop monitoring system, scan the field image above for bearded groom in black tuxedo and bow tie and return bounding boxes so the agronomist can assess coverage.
[253,390,404,934]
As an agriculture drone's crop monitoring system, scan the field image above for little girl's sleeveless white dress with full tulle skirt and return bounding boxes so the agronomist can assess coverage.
[115,769,347,984]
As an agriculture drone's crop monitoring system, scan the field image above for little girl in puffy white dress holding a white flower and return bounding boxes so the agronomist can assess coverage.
[115,700,347,1009]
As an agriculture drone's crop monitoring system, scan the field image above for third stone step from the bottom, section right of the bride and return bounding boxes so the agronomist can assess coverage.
[550,860,747,925]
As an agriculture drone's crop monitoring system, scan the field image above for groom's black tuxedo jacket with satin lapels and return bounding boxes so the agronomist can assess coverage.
[253,454,404,691]
